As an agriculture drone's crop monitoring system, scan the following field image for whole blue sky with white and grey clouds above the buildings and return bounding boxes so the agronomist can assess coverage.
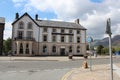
[0,0,120,39]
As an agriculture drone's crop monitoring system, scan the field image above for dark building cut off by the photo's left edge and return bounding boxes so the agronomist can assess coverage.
[0,17,5,55]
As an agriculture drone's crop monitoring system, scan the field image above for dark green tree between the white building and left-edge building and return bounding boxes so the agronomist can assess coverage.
[3,38,12,55]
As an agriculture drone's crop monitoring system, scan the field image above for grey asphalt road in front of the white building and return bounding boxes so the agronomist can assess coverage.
[0,58,120,80]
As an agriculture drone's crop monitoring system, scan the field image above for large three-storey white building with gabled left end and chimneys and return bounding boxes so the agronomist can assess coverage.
[12,13,86,56]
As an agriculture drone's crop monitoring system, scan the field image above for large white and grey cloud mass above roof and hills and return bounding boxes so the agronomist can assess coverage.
[13,0,120,38]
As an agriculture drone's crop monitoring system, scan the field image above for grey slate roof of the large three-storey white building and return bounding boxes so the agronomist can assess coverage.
[12,13,86,30]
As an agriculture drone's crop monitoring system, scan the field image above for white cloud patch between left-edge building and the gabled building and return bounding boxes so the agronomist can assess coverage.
[4,22,12,39]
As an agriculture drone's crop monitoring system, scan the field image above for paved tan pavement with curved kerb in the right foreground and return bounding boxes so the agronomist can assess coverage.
[61,64,120,80]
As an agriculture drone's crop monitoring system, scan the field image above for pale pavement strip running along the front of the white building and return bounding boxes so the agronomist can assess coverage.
[0,56,120,61]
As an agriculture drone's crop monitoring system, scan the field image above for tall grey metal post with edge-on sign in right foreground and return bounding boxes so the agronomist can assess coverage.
[106,18,113,80]
